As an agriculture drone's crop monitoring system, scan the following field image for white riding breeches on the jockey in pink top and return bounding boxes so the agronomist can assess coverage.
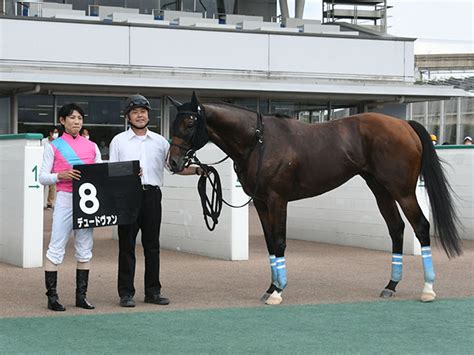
[46,191,93,265]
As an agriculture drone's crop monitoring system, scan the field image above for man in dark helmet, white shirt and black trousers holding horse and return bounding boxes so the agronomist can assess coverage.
[109,95,203,307]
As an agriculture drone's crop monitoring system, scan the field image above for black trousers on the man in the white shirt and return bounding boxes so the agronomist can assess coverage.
[118,188,161,297]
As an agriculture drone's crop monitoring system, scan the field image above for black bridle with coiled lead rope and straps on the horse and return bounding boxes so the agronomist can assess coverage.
[171,107,265,231]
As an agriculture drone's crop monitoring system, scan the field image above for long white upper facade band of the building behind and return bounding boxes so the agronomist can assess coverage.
[0,18,414,90]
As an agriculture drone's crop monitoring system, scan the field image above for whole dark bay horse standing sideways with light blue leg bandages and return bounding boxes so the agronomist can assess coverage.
[168,94,461,304]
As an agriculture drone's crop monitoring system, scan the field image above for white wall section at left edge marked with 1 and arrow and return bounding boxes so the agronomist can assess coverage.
[0,135,44,267]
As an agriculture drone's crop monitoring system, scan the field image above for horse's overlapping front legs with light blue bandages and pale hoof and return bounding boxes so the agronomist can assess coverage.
[255,196,288,304]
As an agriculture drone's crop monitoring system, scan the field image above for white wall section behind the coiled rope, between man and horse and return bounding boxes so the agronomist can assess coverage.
[160,144,249,260]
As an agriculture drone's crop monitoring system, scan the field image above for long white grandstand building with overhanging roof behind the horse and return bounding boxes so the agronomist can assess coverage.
[0,0,468,144]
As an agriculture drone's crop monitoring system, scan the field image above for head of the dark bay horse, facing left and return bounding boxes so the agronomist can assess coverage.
[168,92,209,173]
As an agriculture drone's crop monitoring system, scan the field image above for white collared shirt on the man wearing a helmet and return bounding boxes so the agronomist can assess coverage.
[109,128,170,186]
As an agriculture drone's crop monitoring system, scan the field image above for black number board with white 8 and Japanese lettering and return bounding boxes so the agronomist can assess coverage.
[72,160,142,229]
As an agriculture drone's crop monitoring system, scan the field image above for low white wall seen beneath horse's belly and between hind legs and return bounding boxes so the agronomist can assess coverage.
[287,176,428,255]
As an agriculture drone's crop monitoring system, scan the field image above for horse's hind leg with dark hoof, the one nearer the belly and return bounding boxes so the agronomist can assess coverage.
[363,176,405,298]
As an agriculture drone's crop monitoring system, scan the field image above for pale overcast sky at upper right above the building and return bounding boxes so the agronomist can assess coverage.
[284,0,474,54]
